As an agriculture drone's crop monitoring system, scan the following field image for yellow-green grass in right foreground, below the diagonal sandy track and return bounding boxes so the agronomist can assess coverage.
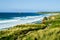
[22,28,60,40]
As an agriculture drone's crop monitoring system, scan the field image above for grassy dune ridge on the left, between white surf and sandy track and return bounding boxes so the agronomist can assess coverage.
[0,24,46,40]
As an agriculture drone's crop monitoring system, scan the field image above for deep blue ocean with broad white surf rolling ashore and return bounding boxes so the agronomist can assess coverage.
[0,13,51,29]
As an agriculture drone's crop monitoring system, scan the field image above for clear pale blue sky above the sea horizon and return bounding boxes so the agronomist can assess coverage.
[0,0,60,12]
